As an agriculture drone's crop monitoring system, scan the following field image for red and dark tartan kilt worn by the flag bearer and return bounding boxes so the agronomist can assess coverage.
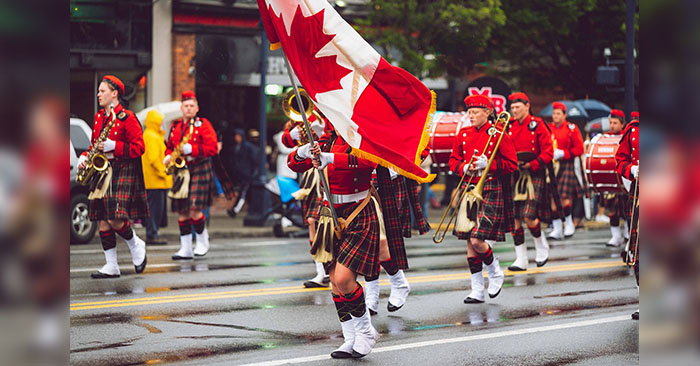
[331,201,379,276]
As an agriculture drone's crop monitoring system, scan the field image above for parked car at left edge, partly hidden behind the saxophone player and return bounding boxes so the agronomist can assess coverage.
[70,118,98,244]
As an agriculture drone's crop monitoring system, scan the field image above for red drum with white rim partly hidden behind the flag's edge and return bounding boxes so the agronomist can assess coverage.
[430,112,471,174]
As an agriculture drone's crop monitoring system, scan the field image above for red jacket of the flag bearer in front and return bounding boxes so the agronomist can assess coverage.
[287,129,377,194]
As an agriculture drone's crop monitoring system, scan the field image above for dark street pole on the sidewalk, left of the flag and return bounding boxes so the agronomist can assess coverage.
[243,29,271,226]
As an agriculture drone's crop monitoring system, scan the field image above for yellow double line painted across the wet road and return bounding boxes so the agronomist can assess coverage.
[70,260,624,311]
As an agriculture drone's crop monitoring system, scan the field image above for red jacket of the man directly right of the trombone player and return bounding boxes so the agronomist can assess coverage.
[508,114,552,172]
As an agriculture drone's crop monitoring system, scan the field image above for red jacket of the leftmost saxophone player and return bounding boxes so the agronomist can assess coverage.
[81,104,145,160]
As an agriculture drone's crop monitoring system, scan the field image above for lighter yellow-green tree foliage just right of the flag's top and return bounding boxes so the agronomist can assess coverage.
[356,0,506,77]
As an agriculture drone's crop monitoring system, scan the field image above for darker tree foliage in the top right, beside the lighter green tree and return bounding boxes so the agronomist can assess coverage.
[489,0,625,97]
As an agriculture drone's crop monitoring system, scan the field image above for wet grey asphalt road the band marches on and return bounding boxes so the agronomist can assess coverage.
[70,230,639,366]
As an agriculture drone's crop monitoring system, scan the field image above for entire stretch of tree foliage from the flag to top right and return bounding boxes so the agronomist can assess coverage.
[356,0,625,97]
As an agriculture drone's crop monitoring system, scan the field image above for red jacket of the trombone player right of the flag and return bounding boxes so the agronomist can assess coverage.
[449,121,518,184]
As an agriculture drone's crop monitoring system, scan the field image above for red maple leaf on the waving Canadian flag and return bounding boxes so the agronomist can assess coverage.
[269,6,352,101]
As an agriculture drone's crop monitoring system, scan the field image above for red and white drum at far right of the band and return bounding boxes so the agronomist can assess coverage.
[585,133,630,193]
